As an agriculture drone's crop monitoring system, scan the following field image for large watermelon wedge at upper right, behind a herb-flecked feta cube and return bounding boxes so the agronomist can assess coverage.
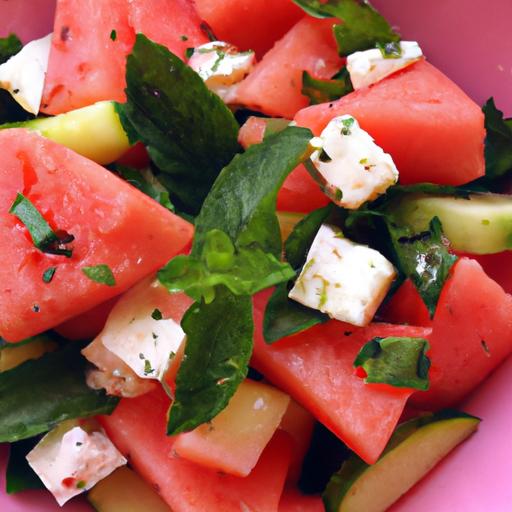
[295,61,485,185]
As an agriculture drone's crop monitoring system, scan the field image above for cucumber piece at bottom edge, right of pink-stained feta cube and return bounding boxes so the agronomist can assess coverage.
[87,466,171,512]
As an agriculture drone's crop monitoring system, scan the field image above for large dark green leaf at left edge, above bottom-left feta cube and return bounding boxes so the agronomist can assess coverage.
[0,343,118,443]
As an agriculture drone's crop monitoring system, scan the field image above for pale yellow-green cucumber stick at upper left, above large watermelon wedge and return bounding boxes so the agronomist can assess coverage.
[0,101,130,165]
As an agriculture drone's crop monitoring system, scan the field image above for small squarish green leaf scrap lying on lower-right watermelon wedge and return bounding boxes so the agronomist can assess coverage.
[354,337,430,391]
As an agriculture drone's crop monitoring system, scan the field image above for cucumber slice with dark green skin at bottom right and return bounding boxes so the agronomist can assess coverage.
[323,411,480,512]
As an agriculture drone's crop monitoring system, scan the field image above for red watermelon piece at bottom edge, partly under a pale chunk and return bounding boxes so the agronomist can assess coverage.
[100,389,291,512]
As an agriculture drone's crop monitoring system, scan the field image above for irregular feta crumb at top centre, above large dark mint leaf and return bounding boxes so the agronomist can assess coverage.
[188,41,255,100]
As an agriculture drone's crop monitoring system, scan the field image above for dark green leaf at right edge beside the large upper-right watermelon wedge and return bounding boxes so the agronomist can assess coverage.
[482,98,512,179]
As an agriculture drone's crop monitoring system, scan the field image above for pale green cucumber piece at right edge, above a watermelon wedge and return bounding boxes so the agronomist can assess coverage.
[389,194,512,254]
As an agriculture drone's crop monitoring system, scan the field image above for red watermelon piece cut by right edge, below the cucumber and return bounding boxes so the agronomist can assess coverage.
[411,258,512,410]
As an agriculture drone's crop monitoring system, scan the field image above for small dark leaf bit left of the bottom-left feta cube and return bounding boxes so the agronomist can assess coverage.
[5,437,44,494]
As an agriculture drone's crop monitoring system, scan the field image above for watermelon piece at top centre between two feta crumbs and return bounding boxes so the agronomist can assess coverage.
[235,17,342,119]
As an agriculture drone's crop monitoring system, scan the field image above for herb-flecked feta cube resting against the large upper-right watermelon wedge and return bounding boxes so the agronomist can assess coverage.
[309,115,398,209]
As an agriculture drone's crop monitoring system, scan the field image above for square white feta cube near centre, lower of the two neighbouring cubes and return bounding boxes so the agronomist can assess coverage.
[289,224,396,326]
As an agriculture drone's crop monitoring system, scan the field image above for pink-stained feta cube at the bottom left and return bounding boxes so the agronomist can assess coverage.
[27,422,127,506]
